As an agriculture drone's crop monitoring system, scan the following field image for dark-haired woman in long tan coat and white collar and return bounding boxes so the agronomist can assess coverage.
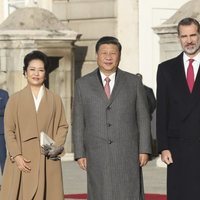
[0,51,68,200]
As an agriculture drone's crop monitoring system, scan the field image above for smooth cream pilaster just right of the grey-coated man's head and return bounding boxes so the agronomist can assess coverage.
[117,0,139,73]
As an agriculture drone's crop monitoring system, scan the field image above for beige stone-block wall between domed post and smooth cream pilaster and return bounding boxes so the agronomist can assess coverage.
[52,0,116,78]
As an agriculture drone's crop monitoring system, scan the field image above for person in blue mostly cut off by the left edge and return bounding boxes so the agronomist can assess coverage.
[0,89,8,174]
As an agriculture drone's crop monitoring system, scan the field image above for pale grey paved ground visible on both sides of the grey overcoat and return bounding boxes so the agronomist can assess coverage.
[0,156,166,194]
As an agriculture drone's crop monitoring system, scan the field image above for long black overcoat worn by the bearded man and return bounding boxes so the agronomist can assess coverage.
[156,53,200,200]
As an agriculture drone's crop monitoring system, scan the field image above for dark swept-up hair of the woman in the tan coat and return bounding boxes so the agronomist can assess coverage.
[23,51,49,77]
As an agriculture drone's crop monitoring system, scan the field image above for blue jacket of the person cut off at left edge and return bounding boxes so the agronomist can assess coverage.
[0,89,8,134]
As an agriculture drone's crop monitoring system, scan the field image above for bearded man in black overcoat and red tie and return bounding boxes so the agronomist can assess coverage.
[156,18,200,200]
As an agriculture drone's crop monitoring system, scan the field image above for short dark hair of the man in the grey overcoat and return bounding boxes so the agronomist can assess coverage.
[95,36,122,53]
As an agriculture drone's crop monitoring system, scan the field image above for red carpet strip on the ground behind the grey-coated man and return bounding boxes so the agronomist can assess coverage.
[65,194,167,200]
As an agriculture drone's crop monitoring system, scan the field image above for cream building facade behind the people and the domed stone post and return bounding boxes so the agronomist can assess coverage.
[0,0,191,156]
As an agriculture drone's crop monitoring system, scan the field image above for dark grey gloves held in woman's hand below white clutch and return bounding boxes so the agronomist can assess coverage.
[42,144,64,160]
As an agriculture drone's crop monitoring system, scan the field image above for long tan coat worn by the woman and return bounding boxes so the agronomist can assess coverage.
[0,86,68,200]
